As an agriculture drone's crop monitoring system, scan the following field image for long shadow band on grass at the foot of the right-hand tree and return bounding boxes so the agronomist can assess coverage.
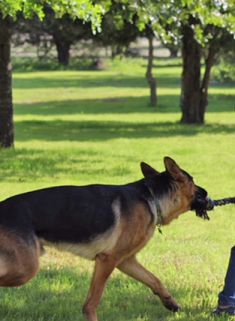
[16,120,234,141]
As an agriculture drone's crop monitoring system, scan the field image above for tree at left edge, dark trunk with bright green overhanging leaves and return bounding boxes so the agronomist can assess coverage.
[0,0,103,147]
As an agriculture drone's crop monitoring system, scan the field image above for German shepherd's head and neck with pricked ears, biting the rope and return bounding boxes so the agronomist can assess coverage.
[141,157,213,224]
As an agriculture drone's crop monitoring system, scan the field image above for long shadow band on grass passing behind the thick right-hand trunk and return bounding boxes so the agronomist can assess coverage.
[15,91,234,116]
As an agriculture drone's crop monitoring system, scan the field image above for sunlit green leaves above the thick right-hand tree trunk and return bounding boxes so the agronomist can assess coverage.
[140,0,235,45]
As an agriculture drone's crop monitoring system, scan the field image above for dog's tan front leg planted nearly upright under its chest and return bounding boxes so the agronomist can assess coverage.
[83,254,117,321]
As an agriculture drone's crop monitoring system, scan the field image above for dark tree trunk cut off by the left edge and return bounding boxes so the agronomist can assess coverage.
[0,14,14,147]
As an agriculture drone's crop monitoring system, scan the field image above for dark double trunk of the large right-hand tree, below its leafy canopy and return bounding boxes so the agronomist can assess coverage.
[181,16,234,124]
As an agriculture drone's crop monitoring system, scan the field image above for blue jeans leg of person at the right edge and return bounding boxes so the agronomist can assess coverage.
[219,246,235,307]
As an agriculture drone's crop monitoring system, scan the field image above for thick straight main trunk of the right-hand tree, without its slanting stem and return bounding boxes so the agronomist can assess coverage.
[181,25,204,124]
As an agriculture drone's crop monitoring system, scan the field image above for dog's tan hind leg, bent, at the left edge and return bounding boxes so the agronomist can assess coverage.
[0,229,40,287]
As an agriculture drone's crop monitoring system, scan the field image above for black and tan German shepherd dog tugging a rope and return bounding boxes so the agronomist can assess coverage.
[0,157,210,321]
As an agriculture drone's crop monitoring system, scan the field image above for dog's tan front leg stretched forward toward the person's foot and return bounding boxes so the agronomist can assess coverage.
[117,256,180,312]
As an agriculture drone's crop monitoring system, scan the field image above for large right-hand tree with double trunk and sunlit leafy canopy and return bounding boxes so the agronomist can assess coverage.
[123,0,235,124]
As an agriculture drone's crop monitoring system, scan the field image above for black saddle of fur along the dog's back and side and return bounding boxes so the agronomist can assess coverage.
[0,180,153,243]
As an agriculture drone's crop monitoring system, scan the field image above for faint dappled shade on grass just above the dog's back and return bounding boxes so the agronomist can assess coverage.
[0,147,119,184]
